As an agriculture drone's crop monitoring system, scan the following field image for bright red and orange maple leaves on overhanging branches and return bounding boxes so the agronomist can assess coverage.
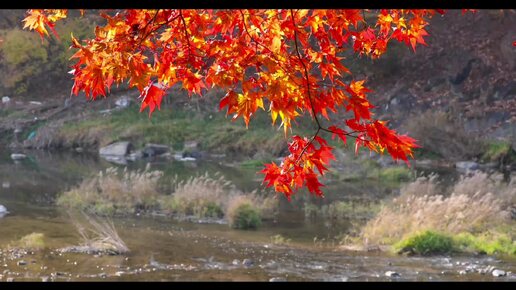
[24,9,444,198]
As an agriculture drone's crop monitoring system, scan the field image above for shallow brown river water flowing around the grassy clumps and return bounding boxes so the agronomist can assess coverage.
[0,151,516,281]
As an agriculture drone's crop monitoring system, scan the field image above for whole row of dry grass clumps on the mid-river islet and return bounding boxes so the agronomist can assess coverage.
[57,166,278,228]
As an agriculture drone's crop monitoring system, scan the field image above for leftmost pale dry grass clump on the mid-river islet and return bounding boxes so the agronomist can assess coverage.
[57,165,163,215]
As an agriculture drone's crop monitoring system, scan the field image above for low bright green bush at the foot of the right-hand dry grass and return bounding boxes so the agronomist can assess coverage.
[394,231,454,256]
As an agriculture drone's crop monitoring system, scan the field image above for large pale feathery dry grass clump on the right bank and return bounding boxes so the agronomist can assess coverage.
[361,173,516,245]
